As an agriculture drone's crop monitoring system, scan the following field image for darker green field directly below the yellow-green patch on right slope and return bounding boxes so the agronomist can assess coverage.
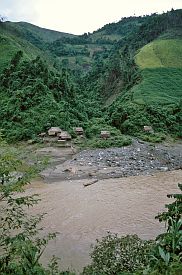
[133,68,182,104]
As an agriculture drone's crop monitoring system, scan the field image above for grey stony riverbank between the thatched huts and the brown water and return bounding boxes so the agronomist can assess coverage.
[39,140,182,183]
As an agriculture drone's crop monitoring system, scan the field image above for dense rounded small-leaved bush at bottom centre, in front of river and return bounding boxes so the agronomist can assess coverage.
[83,234,151,275]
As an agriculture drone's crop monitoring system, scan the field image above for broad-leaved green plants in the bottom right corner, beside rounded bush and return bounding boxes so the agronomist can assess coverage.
[145,184,182,275]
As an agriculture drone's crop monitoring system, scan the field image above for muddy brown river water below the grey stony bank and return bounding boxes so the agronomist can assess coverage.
[26,170,182,272]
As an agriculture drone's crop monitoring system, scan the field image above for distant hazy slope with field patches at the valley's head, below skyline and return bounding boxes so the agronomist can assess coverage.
[42,17,146,73]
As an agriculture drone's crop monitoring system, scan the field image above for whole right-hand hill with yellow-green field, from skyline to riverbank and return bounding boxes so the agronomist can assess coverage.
[103,10,182,141]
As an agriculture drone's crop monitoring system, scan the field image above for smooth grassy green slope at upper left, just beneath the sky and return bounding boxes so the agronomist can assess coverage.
[0,22,72,73]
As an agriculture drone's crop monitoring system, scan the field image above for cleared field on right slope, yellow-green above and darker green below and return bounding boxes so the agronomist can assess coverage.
[133,39,182,104]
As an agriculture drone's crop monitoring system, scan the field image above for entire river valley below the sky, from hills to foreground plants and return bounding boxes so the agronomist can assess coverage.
[0,9,182,275]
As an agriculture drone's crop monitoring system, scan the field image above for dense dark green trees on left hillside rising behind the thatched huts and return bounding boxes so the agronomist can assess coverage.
[0,51,92,140]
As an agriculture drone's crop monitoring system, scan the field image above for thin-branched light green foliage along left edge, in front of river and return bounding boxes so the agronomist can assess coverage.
[0,137,73,275]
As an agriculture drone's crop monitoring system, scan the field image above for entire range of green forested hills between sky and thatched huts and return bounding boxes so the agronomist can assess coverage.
[0,10,182,141]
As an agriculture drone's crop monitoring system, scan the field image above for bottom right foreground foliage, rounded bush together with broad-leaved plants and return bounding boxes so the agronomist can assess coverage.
[82,184,182,275]
